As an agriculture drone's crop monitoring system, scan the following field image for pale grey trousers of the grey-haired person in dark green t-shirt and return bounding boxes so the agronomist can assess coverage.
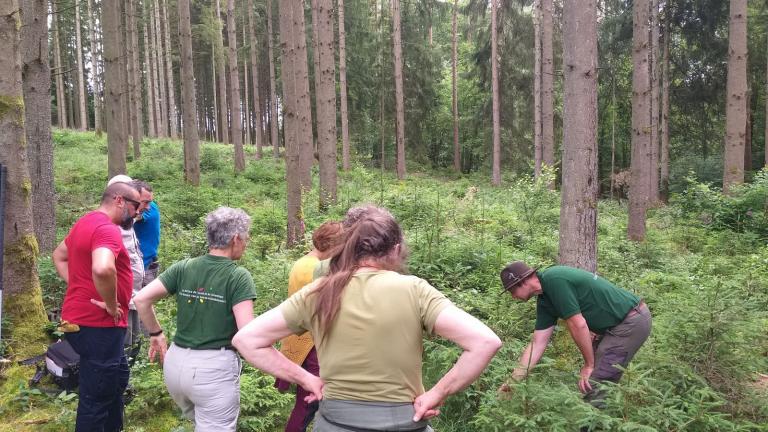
[163,344,241,432]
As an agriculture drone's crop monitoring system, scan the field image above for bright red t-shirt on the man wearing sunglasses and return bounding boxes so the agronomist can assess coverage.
[61,211,133,327]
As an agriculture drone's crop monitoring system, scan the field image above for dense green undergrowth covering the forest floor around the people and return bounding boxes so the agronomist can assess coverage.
[0,131,768,432]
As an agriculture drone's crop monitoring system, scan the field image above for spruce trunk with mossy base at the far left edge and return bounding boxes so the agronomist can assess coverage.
[0,0,50,359]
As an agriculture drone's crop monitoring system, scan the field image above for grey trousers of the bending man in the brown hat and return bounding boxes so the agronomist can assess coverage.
[585,304,652,408]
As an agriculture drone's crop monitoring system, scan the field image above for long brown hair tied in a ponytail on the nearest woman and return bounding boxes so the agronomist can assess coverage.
[312,208,403,334]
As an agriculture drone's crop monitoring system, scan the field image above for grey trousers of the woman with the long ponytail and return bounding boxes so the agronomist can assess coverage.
[312,400,433,432]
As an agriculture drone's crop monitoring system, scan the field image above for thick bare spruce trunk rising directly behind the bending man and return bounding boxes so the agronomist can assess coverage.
[559,0,598,272]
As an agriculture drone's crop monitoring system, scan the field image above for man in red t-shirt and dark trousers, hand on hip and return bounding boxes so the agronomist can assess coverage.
[53,183,140,432]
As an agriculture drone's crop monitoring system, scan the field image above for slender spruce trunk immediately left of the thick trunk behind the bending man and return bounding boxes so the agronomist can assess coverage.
[541,0,555,181]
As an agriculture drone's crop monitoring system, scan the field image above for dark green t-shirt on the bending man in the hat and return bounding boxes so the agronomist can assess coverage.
[536,266,640,334]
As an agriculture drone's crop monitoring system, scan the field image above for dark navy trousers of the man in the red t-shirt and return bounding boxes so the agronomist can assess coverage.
[67,327,129,432]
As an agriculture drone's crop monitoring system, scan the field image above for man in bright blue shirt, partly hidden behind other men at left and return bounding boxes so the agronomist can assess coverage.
[133,181,160,286]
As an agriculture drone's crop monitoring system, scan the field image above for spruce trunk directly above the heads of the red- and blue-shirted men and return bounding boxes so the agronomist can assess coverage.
[101,2,128,177]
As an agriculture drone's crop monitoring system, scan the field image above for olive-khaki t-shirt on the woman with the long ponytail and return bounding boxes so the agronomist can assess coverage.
[280,271,451,402]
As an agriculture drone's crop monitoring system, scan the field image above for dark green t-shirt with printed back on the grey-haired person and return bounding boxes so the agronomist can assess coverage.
[158,255,256,349]
